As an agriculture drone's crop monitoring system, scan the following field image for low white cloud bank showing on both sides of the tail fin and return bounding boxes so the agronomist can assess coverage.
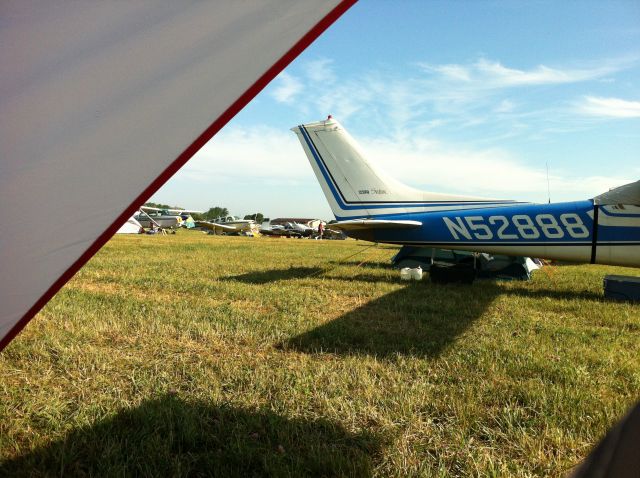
[178,126,632,202]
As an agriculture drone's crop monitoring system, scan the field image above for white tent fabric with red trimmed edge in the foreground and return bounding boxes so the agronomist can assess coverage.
[0,0,354,350]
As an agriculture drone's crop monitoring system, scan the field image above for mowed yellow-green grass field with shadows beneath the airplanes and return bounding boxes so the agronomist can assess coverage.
[0,231,640,476]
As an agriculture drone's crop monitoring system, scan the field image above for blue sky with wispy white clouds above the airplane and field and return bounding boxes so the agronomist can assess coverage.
[152,0,640,219]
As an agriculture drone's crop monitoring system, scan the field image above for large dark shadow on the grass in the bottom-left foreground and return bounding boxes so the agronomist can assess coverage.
[0,395,381,477]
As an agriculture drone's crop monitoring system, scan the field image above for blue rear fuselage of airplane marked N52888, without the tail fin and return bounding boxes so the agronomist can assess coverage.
[349,200,640,267]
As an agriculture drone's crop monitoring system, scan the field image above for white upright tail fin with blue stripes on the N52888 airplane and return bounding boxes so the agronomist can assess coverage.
[291,117,512,220]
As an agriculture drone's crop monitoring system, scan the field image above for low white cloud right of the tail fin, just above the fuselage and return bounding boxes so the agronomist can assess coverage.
[362,134,632,202]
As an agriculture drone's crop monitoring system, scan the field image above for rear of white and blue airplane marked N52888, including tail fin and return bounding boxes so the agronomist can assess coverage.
[292,116,640,267]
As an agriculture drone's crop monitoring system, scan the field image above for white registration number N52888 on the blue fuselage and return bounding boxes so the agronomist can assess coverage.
[442,213,589,241]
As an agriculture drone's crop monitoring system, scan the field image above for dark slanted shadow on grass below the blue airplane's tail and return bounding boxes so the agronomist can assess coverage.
[278,283,501,357]
